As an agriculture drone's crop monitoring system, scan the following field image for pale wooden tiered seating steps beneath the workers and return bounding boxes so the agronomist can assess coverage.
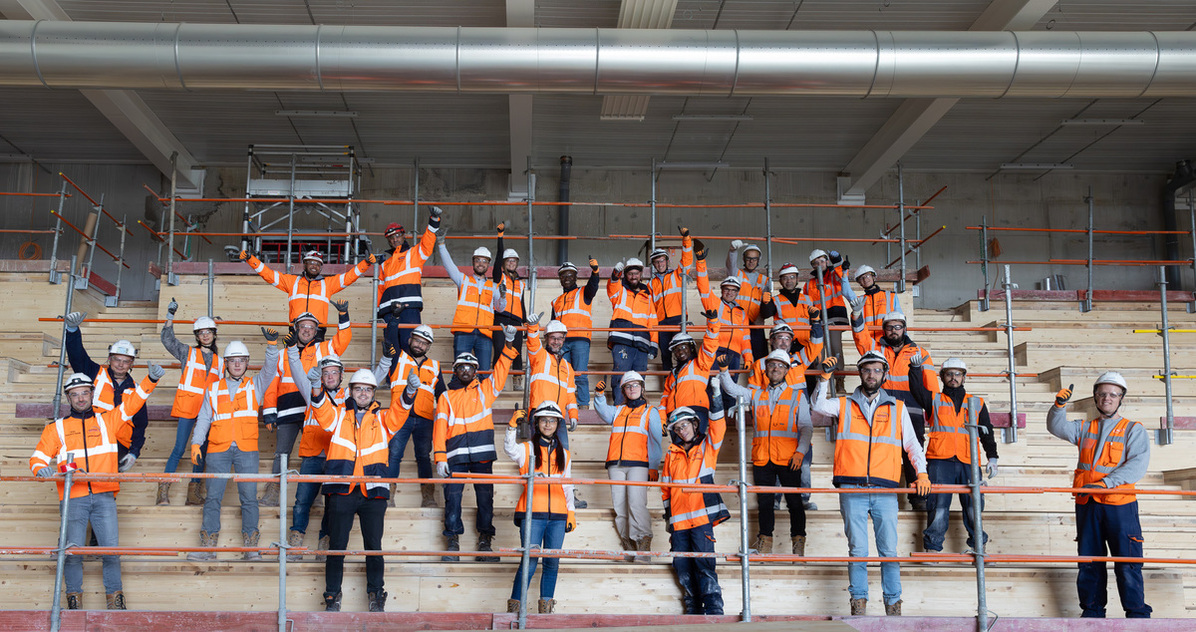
[0,265,1196,618]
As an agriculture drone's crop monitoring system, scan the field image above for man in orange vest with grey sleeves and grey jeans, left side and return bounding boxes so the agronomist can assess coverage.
[187,327,279,561]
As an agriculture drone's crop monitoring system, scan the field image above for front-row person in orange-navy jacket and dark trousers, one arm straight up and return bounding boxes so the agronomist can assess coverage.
[660,392,731,614]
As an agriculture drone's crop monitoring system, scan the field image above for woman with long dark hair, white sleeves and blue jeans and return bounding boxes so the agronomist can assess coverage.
[502,401,578,614]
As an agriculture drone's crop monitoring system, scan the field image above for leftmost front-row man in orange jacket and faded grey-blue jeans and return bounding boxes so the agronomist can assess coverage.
[29,363,166,610]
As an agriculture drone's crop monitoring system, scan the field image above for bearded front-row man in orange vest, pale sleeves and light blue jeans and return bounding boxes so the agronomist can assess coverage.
[812,351,930,616]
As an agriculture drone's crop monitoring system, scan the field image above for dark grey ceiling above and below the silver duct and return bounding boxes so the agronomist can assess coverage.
[0,0,1196,197]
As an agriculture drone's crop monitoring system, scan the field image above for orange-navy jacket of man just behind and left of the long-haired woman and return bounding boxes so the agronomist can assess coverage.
[432,346,518,466]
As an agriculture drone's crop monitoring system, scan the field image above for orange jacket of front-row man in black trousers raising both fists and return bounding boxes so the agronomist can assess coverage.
[311,389,411,498]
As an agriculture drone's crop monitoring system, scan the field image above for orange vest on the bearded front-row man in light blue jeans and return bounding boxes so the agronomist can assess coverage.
[831,397,905,487]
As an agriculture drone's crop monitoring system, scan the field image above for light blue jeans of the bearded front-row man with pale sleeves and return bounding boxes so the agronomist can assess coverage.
[838,485,901,606]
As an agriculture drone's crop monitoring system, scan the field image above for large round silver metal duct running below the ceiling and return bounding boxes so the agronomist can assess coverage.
[0,20,1196,98]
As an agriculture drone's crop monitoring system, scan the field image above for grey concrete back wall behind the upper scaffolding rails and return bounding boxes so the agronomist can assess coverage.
[0,160,1176,308]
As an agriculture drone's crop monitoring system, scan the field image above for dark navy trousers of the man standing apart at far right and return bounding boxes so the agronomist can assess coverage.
[1076,500,1152,619]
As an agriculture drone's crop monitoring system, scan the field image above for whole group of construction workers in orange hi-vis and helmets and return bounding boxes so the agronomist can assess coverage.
[30,207,1151,616]
